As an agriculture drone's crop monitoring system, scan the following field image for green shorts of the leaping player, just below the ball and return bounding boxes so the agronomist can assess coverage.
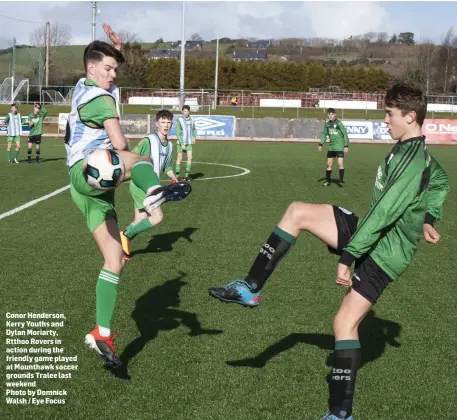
[70,160,117,233]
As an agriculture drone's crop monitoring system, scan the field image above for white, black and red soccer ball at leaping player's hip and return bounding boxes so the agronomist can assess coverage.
[83,149,125,191]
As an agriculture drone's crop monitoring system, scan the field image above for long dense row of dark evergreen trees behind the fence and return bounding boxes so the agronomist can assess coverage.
[118,44,390,91]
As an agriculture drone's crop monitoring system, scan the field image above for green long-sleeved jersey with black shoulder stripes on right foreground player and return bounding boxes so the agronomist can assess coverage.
[340,136,450,280]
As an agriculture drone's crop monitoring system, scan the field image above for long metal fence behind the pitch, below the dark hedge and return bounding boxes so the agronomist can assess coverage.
[6,85,457,117]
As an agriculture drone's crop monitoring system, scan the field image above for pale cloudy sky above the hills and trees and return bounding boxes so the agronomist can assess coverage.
[0,0,457,48]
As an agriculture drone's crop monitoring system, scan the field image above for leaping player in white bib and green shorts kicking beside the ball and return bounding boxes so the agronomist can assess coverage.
[65,25,190,367]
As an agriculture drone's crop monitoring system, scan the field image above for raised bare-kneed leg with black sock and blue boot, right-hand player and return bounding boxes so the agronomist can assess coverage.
[209,202,338,306]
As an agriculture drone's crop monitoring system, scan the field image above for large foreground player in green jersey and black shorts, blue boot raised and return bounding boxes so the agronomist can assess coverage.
[209,84,450,420]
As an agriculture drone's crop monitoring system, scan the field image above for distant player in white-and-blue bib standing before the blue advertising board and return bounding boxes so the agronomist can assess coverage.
[176,105,197,181]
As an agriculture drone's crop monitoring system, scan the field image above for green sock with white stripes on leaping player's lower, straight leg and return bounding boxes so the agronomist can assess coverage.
[95,269,119,328]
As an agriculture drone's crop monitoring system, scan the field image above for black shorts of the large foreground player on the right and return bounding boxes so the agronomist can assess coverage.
[329,206,392,305]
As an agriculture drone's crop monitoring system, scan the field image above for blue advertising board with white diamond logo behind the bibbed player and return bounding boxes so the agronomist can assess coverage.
[169,115,235,139]
